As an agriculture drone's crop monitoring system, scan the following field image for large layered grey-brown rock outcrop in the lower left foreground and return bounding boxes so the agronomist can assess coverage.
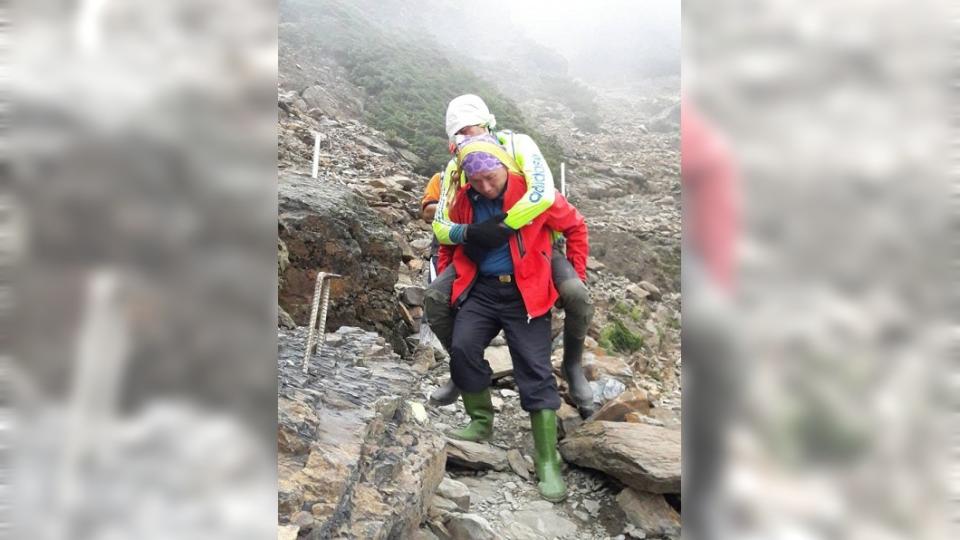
[277,327,446,538]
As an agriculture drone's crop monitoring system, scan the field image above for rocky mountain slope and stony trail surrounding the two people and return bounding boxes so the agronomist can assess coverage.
[278,65,680,539]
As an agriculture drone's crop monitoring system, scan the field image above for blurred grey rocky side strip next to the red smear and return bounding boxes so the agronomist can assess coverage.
[683,0,957,538]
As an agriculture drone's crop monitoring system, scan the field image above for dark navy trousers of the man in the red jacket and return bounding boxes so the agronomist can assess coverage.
[450,276,560,412]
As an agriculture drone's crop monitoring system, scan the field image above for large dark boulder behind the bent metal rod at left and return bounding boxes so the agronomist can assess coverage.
[279,173,410,354]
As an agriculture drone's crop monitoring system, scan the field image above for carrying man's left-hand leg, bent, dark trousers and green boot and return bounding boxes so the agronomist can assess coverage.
[447,284,500,441]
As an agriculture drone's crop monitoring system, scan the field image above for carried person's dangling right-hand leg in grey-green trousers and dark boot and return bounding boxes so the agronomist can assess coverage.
[550,249,596,418]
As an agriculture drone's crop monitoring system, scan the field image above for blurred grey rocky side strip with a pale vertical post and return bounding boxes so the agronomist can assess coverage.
[9,0,277,539]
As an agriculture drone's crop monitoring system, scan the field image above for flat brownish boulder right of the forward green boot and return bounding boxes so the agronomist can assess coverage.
[560,422,680,493]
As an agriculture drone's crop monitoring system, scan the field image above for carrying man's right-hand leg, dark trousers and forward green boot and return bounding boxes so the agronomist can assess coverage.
[501,286,567,502]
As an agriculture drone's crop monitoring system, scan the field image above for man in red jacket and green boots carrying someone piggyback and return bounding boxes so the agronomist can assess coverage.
[439,134,589,502]
